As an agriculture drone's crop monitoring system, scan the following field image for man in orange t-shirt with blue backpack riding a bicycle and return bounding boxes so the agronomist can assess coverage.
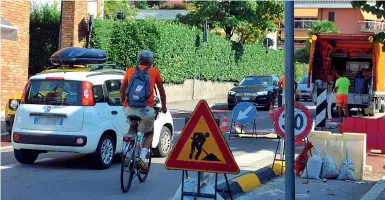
[120,50,167,173]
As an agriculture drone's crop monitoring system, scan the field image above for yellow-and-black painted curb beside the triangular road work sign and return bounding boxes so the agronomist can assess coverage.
[217,161,285,199]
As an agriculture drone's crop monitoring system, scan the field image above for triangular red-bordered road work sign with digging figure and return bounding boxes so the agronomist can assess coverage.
[166,100,239,174]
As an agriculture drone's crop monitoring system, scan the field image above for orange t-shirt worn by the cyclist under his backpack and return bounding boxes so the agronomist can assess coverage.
[122,65,163,108]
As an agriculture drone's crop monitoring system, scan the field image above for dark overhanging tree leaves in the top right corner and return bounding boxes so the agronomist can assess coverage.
[351,1,385,52]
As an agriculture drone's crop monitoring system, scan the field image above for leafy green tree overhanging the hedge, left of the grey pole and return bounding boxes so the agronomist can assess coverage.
[178,0,283,43]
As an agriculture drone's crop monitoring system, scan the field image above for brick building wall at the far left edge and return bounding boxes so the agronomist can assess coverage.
[0,0,31,112]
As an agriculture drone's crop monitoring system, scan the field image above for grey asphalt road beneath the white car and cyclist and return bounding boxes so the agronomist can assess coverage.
[1,105,277,200]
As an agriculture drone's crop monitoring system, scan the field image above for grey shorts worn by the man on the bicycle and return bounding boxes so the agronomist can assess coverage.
[123,106,155,133]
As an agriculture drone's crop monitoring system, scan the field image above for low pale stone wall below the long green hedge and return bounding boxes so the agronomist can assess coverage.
[164,79,234,102]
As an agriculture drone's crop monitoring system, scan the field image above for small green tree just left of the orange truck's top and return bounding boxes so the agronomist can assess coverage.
[294,20,339,63]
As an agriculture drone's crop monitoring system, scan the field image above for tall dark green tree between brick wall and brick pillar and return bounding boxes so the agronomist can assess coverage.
[28,1,60,75]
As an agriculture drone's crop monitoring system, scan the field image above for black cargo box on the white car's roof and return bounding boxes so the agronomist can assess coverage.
[50,47,107,65]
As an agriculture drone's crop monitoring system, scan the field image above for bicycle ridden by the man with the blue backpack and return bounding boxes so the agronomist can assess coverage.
[120,109,159,193]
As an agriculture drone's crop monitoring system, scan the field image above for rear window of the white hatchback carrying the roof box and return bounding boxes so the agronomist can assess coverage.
[26,80,82,106]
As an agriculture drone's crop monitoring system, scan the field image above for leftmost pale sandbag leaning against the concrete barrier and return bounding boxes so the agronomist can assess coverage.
[301,147,322,180]
